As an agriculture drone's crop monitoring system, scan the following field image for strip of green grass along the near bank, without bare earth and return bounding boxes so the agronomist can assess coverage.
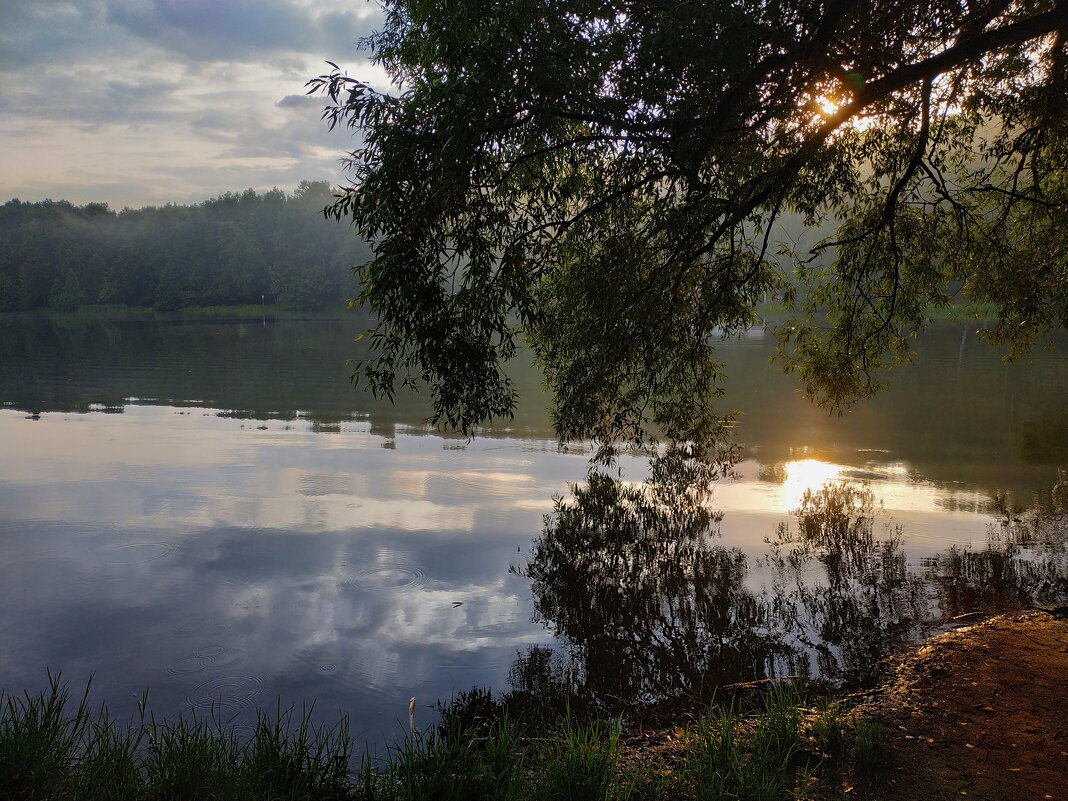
[0,676,885,801]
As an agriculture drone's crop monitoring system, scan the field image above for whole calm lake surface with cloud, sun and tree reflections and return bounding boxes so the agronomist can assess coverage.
[0,315,1068,745]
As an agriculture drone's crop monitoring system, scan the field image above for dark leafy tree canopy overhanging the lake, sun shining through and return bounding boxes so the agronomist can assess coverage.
[310,0,1068,452]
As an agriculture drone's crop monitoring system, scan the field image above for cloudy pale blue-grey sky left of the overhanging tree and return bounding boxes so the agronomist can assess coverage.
[0,0,389,209]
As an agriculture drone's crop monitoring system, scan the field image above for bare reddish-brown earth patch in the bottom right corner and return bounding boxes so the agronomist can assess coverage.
[868,612,1068,801]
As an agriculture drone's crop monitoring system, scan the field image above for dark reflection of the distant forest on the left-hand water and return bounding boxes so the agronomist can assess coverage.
[0,313,549,438]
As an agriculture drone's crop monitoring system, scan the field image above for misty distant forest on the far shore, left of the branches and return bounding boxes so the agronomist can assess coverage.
[0,180,368,312]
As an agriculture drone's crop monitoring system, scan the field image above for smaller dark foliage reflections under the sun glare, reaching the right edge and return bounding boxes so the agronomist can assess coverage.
[768,482,1068,684]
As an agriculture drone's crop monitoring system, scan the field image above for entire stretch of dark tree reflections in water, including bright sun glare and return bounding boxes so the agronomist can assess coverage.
[512,460,1068,710]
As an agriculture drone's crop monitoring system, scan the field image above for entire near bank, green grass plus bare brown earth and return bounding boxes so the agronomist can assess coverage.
[0,608,1068,801]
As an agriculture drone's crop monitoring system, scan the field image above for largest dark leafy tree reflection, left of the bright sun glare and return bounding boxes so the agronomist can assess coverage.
[514,451,792,713]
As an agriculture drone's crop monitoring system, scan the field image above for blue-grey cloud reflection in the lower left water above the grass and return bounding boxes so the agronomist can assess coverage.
[0,516,536,738]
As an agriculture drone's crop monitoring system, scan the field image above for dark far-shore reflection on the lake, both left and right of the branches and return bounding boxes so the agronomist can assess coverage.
[6,315,1068,500]
